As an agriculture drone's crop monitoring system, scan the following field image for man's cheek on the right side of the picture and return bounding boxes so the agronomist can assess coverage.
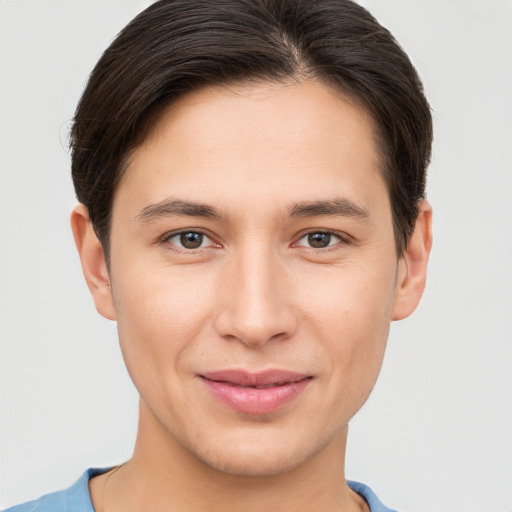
[302,262,395,382]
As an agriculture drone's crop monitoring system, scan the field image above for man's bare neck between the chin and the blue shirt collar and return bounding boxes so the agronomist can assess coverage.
[91,404,367,512]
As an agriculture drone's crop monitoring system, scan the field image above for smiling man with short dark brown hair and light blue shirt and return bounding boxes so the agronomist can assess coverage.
[7,0,432,512]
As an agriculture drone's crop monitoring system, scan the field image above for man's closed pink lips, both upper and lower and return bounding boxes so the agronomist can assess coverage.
[200,370,312,414]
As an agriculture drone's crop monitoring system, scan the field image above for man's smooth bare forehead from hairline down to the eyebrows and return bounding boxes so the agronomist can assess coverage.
[118,81,387,215]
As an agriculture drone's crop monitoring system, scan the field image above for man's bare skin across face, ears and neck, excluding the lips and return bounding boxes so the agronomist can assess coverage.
[72,81,431,512]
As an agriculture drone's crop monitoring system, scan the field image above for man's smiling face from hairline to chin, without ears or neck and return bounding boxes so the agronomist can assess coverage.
[79,82,424,475]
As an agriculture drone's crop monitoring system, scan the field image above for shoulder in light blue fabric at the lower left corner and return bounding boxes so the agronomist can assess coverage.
[4,468,108,512]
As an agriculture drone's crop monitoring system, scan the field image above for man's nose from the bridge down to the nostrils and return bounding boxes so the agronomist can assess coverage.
[215,245,297,347]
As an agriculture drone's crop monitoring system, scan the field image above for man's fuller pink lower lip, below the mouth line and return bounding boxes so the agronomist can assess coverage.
[202,378,311,414]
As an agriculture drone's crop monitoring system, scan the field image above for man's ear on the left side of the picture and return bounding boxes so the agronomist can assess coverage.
[71,204,116,320]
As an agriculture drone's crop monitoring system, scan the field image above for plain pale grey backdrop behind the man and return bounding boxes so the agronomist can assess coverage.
[0,0,512,512]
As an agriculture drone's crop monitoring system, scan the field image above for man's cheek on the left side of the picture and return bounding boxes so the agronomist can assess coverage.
[113,271,216,384]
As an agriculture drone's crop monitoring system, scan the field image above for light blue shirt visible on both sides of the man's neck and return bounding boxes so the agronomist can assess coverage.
[4,468,396,512]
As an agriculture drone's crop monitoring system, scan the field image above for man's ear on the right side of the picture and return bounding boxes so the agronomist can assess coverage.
[392,200,432,320]
